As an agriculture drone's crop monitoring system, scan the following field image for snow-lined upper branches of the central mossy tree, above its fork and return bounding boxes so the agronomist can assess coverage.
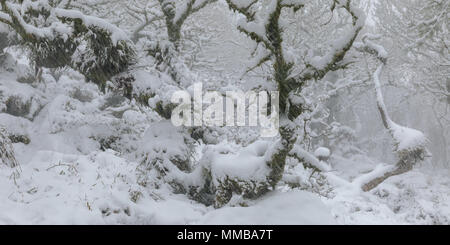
[227,0,365,93]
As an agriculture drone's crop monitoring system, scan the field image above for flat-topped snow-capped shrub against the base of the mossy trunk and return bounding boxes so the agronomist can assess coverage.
[192,140,298,208]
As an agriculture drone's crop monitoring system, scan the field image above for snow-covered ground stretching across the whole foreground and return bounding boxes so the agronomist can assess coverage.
[0,142,450,224]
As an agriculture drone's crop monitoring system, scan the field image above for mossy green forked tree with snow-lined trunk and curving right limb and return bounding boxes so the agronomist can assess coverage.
[209,0,365,203]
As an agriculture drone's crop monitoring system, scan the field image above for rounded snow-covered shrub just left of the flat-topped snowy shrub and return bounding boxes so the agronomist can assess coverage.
[136,120,209,205]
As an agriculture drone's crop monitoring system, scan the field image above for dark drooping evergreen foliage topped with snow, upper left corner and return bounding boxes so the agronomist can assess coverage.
[0,0,134,86]
